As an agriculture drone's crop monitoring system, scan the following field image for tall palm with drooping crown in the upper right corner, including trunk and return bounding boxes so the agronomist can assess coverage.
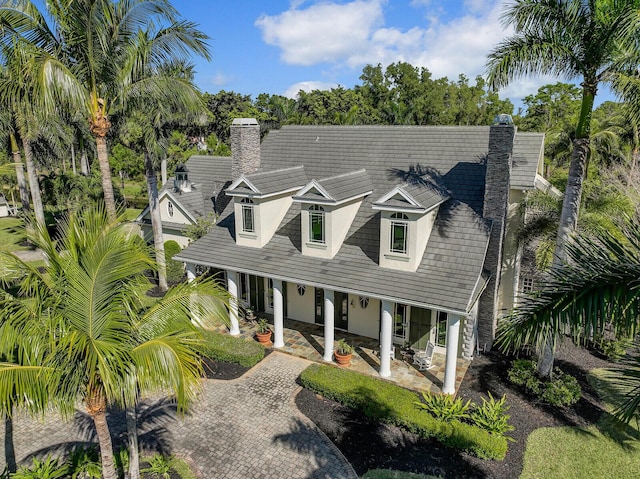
[487,0,640,377]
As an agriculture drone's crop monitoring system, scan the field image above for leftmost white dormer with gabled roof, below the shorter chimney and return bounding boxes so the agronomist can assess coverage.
[225,166,308,248]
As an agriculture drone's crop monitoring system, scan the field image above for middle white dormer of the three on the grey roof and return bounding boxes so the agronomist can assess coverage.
[293,169,373,258]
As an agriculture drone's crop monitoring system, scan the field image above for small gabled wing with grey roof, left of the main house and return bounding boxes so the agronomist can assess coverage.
[136,155,231,248]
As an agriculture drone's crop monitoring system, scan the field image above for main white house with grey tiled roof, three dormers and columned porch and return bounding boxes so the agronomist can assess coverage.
[175,118,544,393]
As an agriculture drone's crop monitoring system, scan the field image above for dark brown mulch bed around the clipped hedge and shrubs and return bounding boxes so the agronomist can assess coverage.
[207,341,615,479]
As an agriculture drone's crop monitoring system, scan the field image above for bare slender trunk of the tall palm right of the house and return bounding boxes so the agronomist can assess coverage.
[538,85,597,378]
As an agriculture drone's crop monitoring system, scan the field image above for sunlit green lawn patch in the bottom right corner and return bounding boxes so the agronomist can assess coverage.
[520,369,640,479]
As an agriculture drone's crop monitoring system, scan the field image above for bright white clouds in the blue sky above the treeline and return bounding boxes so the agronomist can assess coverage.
[256,0,555,101]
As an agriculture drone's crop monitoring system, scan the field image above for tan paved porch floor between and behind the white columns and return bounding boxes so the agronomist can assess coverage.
[221,315,469,393]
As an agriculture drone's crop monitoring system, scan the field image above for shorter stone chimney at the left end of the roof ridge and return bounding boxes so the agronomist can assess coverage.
[231,118,260,180]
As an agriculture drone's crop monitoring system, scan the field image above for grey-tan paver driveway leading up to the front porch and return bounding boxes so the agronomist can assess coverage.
[0,352,357,479]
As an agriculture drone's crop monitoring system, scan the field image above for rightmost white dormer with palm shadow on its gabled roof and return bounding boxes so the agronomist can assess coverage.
[372,181,451,271]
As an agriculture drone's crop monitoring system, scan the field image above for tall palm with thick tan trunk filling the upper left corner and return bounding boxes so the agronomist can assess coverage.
[0,0,210,216]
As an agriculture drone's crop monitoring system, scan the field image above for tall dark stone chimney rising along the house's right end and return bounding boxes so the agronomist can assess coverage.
[478,115,516,350]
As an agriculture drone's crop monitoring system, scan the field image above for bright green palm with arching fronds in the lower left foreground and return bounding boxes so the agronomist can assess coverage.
[0,207,226,479]
